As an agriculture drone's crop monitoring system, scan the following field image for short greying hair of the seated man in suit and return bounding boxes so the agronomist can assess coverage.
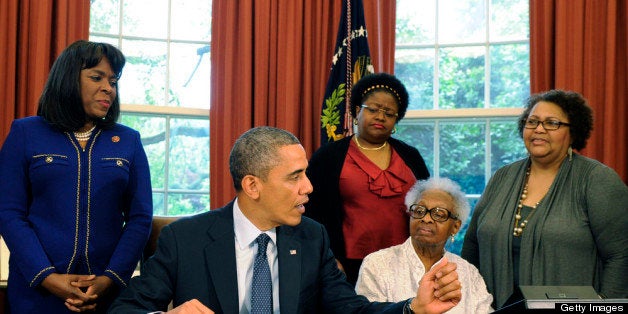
[229,126,301,191]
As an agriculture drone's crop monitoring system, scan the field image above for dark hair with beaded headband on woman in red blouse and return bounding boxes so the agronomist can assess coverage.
[351,72,408,123]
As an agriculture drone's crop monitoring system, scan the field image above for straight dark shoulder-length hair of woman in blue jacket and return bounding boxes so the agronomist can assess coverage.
[37,40,126,131]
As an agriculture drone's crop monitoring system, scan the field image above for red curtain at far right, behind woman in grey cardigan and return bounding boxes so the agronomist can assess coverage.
[530,0,628,182]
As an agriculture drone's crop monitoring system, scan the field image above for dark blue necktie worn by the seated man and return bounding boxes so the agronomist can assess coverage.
[251,233,273,314]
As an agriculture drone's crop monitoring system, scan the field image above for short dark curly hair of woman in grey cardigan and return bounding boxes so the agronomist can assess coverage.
[519,89,593,150]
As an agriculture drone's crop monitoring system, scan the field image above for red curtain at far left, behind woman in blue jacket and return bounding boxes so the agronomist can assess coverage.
[0,0,90,145]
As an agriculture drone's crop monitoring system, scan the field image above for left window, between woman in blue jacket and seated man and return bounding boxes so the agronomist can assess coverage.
[90,0,212,216]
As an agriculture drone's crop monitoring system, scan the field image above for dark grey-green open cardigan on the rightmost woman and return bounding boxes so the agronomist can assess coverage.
[461,154,628,308]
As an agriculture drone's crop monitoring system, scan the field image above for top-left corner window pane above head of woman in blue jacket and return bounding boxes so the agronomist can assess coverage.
[89,0,120,35]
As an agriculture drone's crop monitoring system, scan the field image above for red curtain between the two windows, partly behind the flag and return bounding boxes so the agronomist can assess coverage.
[210,0,395,207]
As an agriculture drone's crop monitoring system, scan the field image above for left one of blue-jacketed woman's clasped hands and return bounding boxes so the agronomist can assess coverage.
[41,273,97,312]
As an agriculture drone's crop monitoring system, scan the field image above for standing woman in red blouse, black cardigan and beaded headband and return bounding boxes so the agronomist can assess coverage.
[305,73,429,284]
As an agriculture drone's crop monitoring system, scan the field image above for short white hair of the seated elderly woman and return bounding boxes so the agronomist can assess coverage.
[405,177,470,224]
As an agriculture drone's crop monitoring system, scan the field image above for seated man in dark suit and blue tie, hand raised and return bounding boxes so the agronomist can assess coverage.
[110,127,461,314]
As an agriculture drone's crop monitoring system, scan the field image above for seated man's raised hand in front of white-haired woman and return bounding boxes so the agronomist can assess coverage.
[411,257,462,314]
